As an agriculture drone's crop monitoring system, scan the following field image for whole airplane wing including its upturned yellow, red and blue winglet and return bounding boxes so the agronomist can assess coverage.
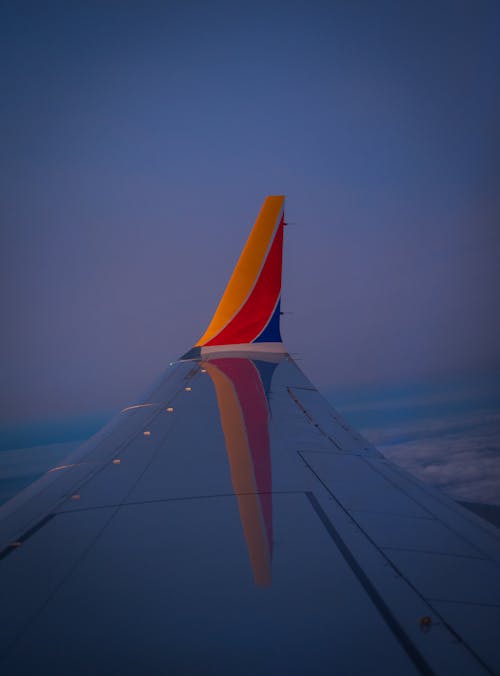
[0,196,500,676]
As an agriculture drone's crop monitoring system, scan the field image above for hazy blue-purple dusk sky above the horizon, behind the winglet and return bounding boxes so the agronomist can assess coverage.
[0,0,500,428]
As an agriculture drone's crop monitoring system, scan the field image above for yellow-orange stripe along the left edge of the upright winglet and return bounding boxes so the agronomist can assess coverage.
[195,195,285,347]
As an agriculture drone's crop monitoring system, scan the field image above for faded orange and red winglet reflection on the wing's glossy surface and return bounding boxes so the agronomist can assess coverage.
[202,357,275,586]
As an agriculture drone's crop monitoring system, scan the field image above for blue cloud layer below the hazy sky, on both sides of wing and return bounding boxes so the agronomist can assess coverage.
[0,374,500,506]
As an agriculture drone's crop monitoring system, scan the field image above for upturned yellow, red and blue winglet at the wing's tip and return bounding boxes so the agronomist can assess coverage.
[183,195,285,359]
